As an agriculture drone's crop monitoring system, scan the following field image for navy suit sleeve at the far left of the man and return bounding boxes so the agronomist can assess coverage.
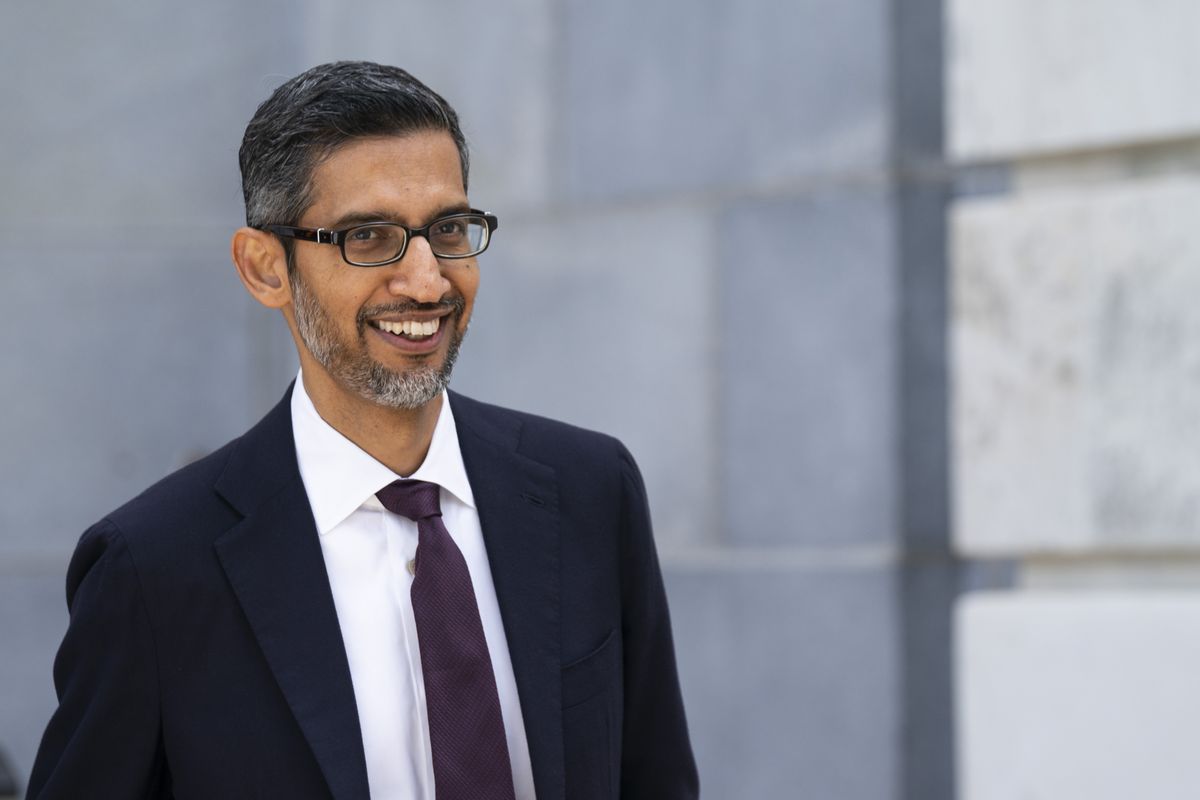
[28,522,168,800]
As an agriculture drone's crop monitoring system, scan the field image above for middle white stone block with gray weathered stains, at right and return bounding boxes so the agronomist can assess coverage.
[952,176,1200,555]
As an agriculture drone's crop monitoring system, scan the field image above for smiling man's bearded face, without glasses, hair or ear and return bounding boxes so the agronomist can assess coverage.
[289,131,479,409]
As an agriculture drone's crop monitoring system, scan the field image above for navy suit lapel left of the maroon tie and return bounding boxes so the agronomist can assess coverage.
[215,391,368,800]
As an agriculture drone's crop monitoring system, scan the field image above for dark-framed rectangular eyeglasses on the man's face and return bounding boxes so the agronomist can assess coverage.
[265,209,500,266]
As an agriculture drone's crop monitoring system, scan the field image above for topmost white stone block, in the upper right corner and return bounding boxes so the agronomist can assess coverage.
[946,0,1200,161]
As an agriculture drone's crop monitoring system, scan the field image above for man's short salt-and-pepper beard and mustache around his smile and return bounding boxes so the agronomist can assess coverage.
[288,272,464,410]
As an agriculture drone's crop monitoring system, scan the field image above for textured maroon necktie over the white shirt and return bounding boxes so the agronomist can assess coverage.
[376,481,514,800]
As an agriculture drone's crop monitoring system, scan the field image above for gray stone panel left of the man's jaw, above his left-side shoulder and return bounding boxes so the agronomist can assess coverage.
[0,243,271,558]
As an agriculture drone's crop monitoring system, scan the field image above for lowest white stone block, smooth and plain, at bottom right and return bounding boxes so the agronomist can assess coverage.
[955,593,1200,800]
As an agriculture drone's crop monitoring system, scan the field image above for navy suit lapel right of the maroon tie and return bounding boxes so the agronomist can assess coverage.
[450,392,565,800]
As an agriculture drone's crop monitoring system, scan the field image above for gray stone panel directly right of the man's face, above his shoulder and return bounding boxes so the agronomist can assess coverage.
[454,206,716,545]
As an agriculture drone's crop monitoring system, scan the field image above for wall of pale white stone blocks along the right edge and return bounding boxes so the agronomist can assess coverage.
[947,0,1200,800]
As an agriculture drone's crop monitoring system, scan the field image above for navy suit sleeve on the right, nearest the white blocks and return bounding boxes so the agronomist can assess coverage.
[620,446,700,800]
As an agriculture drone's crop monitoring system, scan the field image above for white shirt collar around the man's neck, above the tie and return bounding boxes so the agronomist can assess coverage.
[292,373,475,536]
